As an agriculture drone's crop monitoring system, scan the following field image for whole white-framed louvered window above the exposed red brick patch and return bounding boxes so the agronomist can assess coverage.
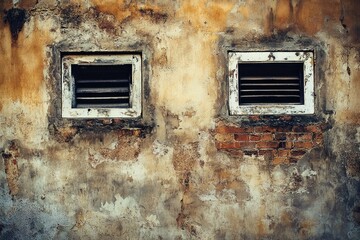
[229,52,314,115]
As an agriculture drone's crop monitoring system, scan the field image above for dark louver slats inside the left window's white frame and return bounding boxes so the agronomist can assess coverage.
[71,64,132,108]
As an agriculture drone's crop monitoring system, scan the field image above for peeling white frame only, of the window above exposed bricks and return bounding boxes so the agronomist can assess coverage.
[228,51,314,115]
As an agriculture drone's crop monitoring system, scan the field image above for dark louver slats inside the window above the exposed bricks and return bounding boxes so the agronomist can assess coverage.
[238,62,304,105]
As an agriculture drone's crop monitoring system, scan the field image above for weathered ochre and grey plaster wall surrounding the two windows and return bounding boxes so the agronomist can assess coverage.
[0,0,360,239]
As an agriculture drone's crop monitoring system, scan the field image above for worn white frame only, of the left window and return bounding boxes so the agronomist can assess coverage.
[61,54,142,118]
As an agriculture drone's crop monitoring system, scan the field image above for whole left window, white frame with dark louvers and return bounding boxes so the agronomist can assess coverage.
[62,54,141,118]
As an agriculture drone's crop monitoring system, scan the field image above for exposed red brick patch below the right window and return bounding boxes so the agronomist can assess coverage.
[215,122,324,165]
